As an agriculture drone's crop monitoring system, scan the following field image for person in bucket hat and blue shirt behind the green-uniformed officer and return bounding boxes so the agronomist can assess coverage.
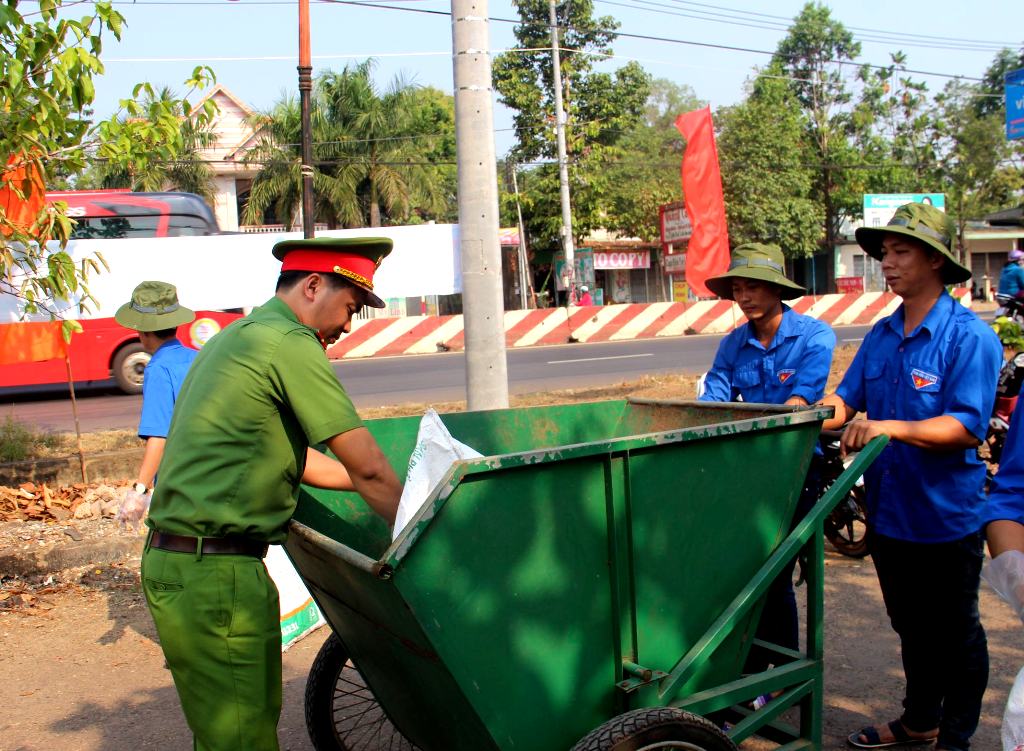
[114,282,199,510]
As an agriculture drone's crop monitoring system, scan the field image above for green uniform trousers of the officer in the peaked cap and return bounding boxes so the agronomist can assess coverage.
[142,546,281,751]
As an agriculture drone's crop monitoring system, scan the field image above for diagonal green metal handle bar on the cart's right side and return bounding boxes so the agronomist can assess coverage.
[658,435,889,697]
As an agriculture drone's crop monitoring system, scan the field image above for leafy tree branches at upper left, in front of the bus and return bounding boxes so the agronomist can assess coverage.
[0,0,213,327]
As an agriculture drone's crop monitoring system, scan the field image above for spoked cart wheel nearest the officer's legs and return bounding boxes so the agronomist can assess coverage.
[306,633,416,751]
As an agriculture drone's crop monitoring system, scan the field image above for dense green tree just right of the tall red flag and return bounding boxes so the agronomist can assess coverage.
[717,69,824,258]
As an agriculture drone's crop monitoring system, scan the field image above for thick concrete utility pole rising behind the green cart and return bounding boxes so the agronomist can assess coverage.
[452,0,509,410]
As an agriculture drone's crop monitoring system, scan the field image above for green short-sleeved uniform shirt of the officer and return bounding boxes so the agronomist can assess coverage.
[148,297,362,543]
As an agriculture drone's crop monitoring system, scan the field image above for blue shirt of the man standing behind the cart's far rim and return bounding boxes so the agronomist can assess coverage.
[700,304,836,404]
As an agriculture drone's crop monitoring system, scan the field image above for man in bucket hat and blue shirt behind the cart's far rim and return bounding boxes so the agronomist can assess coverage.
[700,243,836,684]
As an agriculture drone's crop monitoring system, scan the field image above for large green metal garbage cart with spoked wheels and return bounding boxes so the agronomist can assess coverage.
[287,400,885,751]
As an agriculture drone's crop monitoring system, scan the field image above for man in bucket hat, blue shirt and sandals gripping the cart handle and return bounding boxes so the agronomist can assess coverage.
[822,204,1002,751]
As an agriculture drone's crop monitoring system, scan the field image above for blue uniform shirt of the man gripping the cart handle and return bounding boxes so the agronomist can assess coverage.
[837,292,1002,543]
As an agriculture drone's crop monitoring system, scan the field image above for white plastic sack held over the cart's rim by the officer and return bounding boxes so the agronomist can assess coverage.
[391,409,483,540]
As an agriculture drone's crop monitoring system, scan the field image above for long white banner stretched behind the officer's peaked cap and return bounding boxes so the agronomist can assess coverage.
[0,219,462,323]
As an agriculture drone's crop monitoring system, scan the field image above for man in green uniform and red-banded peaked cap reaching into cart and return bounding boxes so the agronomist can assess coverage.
[142,238,401,751]
